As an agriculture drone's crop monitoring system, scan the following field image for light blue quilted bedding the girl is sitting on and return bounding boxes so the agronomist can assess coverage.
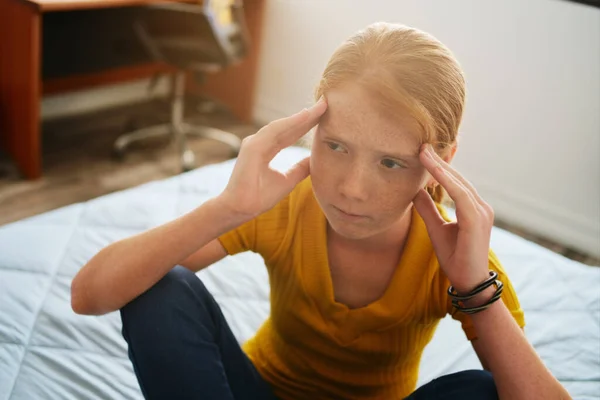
[0,148,600,400]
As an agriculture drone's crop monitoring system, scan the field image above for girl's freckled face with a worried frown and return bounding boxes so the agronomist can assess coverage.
[310,84,428,239]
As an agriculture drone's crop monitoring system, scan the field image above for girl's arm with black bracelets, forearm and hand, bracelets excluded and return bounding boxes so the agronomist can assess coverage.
[413,145,570,400]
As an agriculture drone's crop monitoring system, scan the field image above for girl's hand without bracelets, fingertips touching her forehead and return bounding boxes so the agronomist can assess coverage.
[220,98,327,219]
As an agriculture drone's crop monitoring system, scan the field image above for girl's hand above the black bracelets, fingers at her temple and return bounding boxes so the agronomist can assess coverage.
[413,144,494,293]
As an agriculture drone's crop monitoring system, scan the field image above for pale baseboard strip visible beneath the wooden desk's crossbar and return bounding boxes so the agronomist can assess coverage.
[41,78,169,120]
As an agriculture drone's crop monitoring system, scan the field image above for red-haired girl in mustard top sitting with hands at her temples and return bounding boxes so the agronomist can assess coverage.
[72,23,569,400]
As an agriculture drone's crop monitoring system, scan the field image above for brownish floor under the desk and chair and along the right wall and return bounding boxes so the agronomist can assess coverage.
[0,98,600,266]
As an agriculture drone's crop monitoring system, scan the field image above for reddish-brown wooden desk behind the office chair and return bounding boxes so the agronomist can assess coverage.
[0,0,263,179]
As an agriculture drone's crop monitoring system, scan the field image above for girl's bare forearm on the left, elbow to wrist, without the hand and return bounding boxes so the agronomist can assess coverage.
[71,198,247,315]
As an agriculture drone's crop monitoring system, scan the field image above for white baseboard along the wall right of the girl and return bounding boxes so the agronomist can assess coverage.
[470,177,600,257]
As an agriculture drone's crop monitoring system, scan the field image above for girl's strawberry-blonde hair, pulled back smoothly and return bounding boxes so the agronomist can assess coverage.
[314,22,465,202]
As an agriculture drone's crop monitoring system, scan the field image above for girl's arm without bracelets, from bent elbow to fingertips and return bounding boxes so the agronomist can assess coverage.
[71,96,327,315]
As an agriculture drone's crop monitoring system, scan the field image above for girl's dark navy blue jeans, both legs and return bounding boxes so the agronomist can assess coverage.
[121,266,498,400]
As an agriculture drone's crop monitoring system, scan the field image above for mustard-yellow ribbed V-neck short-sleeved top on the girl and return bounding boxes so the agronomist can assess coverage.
[219,178,525,400]
